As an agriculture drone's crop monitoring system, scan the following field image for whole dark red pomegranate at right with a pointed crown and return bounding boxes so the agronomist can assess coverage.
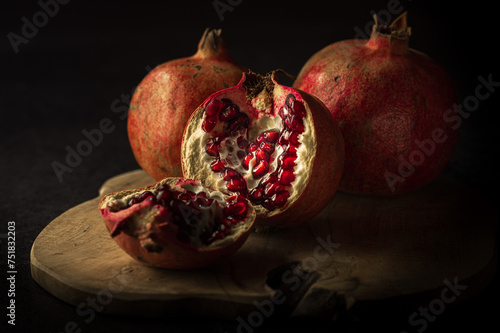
[293,13,458,195]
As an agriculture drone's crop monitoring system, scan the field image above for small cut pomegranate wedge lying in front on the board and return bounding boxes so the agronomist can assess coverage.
[99,177,255,269]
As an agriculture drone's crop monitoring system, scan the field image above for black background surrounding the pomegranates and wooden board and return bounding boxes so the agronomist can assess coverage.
[0,0,500,332]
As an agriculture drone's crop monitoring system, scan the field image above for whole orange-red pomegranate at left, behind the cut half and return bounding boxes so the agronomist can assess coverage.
[127,29,245,180]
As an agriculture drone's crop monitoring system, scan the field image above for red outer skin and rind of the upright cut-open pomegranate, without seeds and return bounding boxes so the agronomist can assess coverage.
[182,70,344,228]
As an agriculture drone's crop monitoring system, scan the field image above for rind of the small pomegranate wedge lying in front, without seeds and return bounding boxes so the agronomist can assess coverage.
[99,177,256,270]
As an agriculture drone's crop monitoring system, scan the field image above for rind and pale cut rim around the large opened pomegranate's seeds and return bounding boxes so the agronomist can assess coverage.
[181,72,344,227]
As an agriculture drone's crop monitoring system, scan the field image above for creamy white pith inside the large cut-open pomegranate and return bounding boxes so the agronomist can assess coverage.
[183,86,316,216]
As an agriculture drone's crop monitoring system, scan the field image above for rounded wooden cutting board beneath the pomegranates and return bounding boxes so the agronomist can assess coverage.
[31,170,497,319]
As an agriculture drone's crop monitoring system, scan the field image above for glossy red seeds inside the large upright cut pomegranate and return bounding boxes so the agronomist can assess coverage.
[202,94,306,210]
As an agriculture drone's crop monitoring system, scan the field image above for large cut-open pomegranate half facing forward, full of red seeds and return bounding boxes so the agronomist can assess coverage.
[181,71,344,226]
